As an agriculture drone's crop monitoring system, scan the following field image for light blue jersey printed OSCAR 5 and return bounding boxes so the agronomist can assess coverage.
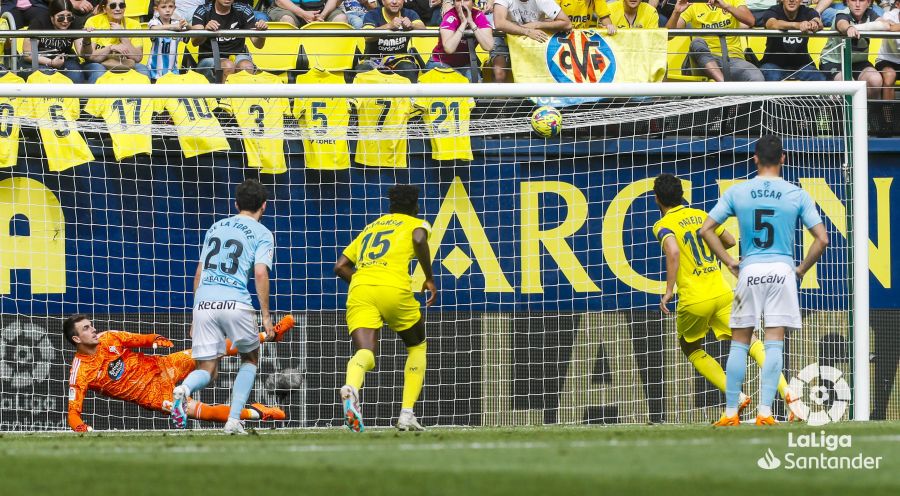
[709,177,822,267]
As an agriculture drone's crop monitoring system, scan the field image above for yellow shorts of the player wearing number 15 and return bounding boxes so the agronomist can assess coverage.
[347,286,422,333]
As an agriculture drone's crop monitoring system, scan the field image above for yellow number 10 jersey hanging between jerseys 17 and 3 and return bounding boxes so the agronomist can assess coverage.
[156,71,231,158]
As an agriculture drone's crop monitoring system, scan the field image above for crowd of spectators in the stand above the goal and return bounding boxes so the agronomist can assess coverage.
[2,0,900,98]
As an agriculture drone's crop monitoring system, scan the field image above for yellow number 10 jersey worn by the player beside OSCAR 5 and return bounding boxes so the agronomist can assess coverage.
[653,205,731,305]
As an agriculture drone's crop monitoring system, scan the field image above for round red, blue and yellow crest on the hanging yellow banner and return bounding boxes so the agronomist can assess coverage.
[547,29,616,83]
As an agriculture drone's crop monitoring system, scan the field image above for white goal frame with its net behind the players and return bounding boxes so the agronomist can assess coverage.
[0,82,870,431]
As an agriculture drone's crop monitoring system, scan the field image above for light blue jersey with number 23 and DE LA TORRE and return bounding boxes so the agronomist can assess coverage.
[194,215,275,307]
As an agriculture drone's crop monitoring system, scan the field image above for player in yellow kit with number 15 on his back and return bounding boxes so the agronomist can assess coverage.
[334,185,437,432]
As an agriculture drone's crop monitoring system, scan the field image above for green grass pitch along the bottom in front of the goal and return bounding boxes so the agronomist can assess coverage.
[0,422,900,496]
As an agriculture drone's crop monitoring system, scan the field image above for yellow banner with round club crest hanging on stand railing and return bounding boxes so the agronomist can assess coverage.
[507,29,668,107]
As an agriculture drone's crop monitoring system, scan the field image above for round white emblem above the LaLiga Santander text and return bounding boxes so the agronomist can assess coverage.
[790,363,850,426]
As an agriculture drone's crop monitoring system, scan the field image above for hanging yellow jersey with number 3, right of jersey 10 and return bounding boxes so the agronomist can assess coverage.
[223,71,291,174]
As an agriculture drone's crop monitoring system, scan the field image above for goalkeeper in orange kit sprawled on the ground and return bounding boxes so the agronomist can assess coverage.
[63,314,294,432]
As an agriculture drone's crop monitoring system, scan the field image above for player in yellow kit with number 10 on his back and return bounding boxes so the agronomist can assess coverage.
[653,174,797,425]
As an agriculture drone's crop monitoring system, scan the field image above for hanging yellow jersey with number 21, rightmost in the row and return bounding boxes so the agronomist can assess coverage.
[415,67,475,160]
